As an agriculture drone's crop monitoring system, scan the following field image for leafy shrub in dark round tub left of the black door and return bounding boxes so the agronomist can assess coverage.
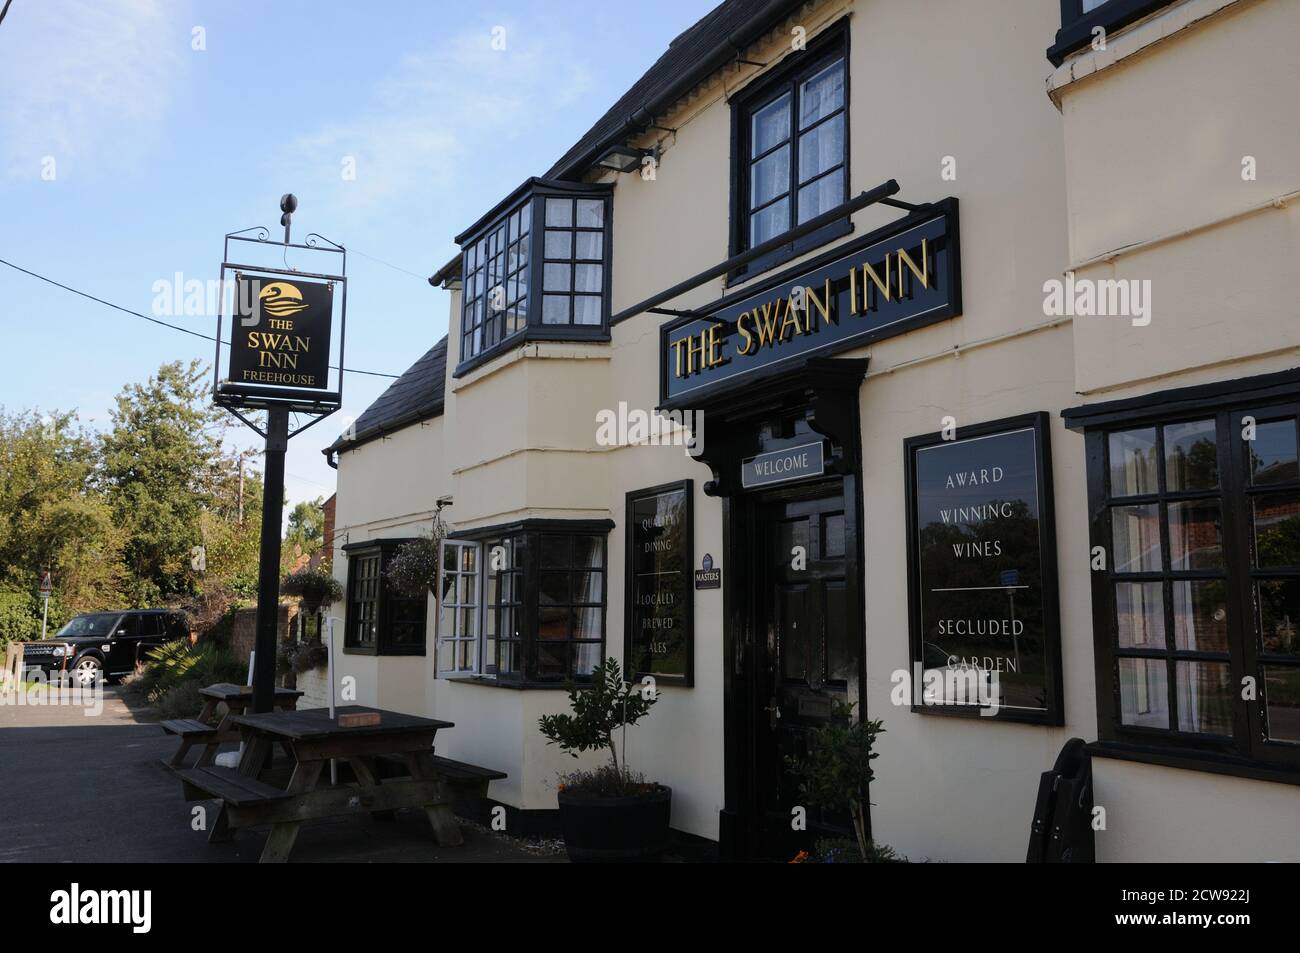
[538,658,672,863]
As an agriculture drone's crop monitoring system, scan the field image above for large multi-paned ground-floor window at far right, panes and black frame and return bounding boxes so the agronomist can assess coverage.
[1086,403,1300,768]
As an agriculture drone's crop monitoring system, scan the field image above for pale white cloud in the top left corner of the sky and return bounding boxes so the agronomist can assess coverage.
[0,0,189,177]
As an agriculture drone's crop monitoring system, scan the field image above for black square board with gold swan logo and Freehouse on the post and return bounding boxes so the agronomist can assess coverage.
[228,274,334,390]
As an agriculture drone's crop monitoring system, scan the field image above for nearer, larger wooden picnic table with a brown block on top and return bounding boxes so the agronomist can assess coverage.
[173,705,506,863]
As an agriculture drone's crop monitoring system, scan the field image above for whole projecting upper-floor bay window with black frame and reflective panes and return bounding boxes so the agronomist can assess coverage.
[456,179,612,374]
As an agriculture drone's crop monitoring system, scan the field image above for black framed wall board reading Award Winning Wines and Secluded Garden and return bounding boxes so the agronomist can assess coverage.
[905,413,1063,724]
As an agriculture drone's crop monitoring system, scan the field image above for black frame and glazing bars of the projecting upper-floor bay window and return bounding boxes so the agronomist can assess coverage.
[452,178,614,377]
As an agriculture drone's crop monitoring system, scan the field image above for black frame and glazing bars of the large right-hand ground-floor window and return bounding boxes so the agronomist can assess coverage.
[1065,377,1300,784]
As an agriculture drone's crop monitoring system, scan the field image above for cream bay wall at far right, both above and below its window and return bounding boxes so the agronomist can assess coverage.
[1052,0,1300,861]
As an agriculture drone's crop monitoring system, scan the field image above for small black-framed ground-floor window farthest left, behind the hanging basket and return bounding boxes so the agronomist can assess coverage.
[343,540,429,655]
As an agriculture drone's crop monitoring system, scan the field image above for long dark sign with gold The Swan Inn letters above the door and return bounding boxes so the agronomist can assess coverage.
[659,199,962,408]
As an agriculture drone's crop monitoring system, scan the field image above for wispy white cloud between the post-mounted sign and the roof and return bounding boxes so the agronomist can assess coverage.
[274,23,592,211]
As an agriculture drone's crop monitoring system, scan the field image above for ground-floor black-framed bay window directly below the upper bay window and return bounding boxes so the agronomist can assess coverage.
[438,520,612,684]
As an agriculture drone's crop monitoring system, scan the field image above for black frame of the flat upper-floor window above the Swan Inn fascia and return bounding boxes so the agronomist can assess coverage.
[727,21,853,286]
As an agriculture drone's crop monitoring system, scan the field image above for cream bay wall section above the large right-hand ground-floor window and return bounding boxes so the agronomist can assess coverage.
[1057,0,1300,399]
